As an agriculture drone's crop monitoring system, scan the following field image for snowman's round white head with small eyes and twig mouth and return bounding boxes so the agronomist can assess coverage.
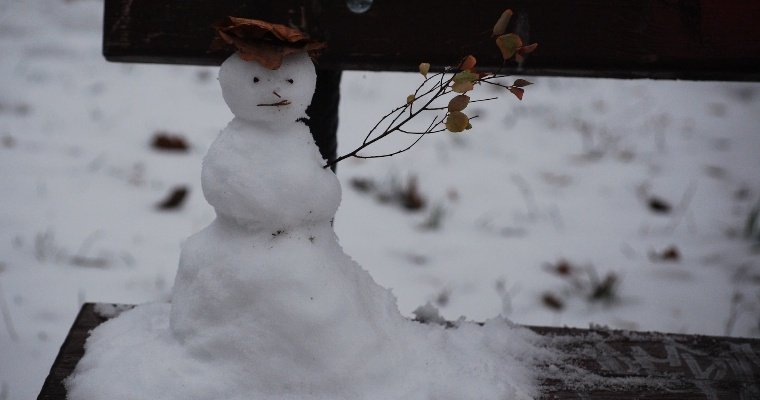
[219,52,317,126]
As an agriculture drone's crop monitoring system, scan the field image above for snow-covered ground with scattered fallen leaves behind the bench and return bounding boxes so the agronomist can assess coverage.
[0,0,760,399]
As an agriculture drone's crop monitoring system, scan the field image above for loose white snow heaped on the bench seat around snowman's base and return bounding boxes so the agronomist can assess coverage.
[69,303,553,400]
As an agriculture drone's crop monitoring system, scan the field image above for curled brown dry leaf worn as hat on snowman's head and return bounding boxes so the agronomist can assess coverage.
[212,17,326,69]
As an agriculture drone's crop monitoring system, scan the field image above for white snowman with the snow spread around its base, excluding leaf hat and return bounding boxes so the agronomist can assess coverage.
[67,18,536,400]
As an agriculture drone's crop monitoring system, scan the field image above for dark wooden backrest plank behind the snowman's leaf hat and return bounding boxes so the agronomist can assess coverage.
[103,0,760,81]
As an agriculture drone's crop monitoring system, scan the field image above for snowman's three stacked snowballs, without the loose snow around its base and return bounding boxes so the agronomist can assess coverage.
[171,53,400,385]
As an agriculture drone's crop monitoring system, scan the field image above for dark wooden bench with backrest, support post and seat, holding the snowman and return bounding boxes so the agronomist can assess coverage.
[38,0,760,400]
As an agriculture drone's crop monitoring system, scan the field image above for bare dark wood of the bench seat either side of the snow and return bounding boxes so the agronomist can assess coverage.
[38,303,760,400]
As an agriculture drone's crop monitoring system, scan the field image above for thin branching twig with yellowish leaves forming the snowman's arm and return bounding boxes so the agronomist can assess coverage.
[324,10,538,168]
